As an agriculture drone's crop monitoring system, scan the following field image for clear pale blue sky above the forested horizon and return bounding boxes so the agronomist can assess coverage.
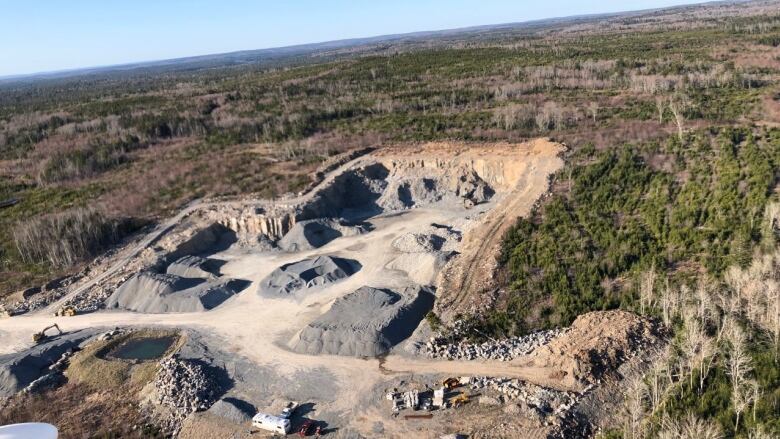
[0,0,694,77]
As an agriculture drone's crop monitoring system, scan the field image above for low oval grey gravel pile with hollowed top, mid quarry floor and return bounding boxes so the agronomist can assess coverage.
[258,256,361,297]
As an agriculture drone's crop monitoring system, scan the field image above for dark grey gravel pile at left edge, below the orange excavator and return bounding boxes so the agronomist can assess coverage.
[0,330,97,397]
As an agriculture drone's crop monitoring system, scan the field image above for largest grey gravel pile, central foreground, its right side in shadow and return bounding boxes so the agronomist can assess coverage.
[292,286,434,357]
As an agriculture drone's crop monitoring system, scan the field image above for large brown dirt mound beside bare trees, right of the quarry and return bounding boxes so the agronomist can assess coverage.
[526,311,663,387]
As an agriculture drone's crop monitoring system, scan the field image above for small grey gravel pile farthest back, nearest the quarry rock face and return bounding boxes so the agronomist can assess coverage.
[277,219,366,252]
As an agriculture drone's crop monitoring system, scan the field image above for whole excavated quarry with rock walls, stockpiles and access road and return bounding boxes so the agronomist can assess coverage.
[0,140,664,437]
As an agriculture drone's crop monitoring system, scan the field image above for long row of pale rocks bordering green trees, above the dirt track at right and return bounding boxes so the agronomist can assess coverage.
[423,328,567,361]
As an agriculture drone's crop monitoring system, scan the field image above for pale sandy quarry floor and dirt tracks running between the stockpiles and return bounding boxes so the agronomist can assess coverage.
[0,143,569,436]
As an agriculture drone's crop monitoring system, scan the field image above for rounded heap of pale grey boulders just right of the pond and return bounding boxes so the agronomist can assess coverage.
[154,356,218,436]
